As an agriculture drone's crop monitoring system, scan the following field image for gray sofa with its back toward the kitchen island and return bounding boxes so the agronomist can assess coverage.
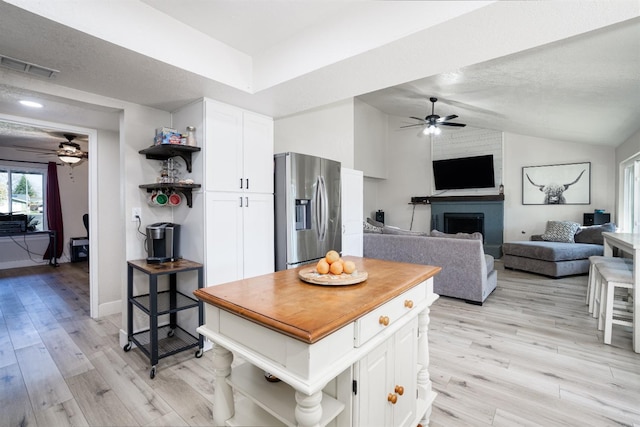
[364,232,498,305]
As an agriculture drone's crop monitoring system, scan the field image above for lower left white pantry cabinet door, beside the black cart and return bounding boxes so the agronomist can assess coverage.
[204,191,243,286]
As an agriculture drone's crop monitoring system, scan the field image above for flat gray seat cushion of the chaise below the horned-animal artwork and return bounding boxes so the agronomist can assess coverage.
[502,241,602,261]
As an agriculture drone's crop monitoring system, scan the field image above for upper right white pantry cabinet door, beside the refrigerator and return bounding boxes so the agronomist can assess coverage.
[242,112,273,193]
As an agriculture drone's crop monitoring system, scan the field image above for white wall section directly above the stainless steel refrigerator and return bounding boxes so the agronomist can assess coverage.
[274,98,354,168]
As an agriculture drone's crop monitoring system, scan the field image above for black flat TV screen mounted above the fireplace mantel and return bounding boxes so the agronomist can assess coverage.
[433,154,496,190]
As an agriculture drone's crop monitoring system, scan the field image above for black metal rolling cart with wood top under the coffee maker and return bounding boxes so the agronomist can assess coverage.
[123,259,204,379]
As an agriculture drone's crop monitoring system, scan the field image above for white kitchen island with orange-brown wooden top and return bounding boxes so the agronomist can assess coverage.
[195,257,440,426]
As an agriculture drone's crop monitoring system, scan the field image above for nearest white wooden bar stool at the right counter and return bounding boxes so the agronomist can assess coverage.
[598,266,633,344]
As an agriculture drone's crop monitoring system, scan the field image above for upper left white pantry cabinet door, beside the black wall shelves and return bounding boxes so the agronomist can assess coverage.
[203,101,244,191]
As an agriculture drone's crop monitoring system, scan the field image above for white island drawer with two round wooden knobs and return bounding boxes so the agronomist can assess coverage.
[354,281,427,347]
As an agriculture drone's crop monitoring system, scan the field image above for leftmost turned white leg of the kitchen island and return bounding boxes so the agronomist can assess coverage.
[212,344,235,426]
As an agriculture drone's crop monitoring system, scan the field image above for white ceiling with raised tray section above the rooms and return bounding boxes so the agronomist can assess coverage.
[0,0,640,152]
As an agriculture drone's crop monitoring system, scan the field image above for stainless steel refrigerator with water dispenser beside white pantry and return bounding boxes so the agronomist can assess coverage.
[274,153,342,271]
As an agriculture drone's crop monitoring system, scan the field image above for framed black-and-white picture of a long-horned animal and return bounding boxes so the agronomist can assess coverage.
[522,162,591,205]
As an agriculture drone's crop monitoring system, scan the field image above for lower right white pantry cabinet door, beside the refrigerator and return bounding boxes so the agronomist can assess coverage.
[242,193,275,278]
